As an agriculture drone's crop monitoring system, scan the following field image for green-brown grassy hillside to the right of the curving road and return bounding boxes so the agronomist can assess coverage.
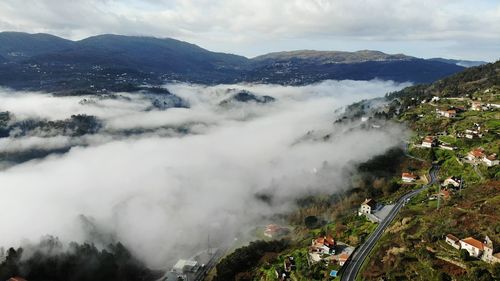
[359,62,500,280]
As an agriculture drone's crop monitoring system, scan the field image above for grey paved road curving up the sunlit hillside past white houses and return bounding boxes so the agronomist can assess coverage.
[341,165,439,281]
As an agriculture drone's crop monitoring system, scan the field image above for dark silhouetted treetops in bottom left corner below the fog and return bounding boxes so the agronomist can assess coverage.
[0,237,161,281]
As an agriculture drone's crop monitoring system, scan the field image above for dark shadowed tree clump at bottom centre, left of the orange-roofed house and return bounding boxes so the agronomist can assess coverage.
[214,239,289,281]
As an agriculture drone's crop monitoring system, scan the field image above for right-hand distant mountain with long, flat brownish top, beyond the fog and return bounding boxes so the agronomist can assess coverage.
[244,50,464,84]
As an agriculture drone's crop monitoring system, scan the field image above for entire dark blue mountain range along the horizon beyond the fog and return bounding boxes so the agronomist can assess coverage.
[0,32,472,92]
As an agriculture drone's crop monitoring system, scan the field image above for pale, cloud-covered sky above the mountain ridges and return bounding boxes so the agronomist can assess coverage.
[0,0,500,61]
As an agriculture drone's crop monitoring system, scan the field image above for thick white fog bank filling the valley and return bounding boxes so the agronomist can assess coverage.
[0,81,408,267]
